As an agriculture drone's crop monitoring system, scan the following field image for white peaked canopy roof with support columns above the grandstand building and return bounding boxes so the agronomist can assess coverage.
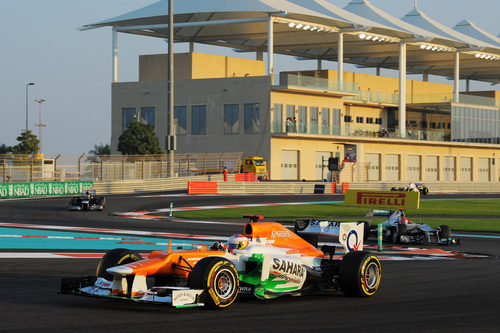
[81,0,500,137]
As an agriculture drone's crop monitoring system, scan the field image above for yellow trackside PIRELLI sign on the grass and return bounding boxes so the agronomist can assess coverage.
[344,190,420,208]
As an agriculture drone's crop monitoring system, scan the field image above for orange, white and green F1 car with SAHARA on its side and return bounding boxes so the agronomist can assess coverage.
[61,215,382,309]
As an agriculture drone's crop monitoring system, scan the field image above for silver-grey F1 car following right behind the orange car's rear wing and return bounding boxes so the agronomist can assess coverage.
[370,209,459,245]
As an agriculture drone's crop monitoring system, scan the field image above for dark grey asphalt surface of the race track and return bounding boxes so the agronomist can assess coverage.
[0,191,500,332]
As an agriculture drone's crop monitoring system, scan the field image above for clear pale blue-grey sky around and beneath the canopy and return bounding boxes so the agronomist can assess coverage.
[0,0,500,155]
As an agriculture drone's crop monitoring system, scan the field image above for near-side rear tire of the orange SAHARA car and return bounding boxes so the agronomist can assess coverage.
[339,251,382,297]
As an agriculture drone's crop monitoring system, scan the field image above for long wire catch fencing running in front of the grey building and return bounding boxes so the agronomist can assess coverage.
[0,153,243,183]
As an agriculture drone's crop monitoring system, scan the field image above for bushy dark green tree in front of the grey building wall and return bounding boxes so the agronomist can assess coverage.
[118,121,162,155]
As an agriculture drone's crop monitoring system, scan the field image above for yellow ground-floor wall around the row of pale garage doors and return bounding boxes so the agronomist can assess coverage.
[270,136,500,182]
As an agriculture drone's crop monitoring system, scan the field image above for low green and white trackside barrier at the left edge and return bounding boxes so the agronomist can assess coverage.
[0,182,94,199]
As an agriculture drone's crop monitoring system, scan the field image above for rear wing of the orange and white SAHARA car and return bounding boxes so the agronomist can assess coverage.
[295,219,365,252]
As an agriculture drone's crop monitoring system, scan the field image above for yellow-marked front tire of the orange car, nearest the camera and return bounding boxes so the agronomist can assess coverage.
[188,257,239,309]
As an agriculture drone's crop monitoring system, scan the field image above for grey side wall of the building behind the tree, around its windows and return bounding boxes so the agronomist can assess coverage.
[111,76,271,159]
